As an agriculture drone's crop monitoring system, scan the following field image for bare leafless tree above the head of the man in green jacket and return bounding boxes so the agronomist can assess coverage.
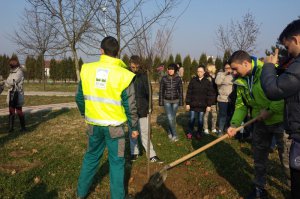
[216,13,260,53]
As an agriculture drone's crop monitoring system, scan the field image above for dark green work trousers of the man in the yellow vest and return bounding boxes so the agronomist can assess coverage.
[77,125,125,199]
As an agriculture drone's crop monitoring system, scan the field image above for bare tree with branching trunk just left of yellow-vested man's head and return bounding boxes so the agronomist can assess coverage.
[27,0,102,80]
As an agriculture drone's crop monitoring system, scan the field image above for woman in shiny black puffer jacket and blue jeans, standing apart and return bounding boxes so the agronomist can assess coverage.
[159,63,183,142]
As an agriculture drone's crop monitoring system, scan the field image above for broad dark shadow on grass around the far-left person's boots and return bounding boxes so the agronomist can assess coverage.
[0,109,70,147]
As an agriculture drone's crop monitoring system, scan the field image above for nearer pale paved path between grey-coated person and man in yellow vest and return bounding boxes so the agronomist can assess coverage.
[0,102,77,116]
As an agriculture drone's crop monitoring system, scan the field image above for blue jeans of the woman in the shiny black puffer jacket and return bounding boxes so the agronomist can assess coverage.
[164,102,178,137]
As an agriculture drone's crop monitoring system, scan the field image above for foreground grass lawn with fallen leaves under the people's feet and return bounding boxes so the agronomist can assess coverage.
[0,106,289,199]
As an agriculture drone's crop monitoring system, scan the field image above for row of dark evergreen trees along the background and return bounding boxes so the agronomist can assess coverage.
[0,51,230,82]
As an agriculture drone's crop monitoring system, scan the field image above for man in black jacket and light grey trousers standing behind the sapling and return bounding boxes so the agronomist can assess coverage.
[129,55,163,163]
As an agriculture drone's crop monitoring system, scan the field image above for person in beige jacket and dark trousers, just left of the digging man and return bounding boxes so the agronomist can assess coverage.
[215,64,233,135]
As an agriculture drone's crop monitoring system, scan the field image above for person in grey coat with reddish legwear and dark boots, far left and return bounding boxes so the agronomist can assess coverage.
[5,57,26,132]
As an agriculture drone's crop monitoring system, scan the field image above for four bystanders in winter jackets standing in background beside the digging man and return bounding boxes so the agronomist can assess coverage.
[159,61,233,142]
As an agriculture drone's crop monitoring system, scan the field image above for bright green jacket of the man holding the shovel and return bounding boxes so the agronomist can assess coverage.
[230,58,283,127]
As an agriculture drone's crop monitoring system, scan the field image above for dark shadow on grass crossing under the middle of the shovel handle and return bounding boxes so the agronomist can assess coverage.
[192,135,253,196]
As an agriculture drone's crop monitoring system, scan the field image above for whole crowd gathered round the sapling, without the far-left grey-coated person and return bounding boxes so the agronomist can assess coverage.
[76,20,300,199]
